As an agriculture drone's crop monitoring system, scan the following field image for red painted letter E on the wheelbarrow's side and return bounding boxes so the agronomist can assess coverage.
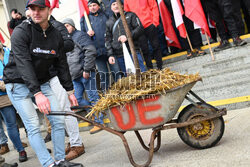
[136,96,164,125]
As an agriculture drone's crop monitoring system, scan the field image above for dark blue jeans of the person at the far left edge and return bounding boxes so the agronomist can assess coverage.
[0,105,24,152]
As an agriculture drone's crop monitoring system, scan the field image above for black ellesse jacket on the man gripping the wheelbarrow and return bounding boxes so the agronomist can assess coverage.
[3,20,73,94]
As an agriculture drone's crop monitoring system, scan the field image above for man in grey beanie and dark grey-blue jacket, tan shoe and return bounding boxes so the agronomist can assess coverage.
[62,18,104,134]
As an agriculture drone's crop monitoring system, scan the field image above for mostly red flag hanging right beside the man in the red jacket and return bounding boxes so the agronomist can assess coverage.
[157,0,181,49]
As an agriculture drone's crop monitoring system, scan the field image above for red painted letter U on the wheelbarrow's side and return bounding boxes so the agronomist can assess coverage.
[111,104,136,130]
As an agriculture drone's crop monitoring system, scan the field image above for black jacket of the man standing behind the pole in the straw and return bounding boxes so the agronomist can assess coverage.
[105,12,144,57]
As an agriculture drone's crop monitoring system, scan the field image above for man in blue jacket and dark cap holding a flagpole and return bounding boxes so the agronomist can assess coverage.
[80,0,120,90]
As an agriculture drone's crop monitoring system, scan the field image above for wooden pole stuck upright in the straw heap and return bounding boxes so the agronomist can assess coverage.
[116,0,140,78]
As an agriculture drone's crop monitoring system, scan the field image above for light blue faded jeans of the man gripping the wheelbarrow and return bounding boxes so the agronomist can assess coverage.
[6,82,65,167]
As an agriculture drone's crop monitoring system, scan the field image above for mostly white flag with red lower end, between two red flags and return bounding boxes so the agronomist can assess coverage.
[171,0,187,38]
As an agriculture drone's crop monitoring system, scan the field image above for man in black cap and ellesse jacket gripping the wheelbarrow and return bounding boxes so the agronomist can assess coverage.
[3,0,83,167]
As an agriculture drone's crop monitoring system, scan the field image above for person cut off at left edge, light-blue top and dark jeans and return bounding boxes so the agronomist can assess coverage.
[0,42,28,162]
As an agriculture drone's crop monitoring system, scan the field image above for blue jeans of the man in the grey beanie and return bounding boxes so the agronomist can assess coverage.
[73,71,103,124]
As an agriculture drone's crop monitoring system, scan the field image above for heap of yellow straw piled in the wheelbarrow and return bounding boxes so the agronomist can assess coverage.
[86,68,201,117]
